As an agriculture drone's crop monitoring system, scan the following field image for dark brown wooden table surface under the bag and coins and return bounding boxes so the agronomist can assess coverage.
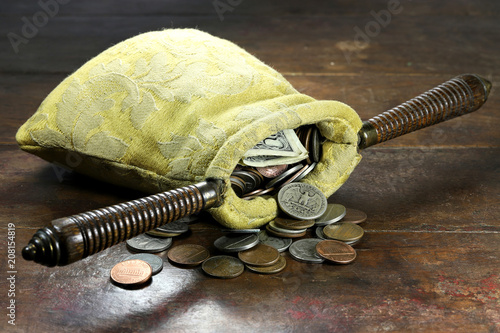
[0,0,500,332]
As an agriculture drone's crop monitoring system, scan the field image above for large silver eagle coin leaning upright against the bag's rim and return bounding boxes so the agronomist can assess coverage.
[278,183,328,220]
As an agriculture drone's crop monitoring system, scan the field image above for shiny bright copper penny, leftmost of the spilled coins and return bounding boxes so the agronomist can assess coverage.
[110,259,153,285]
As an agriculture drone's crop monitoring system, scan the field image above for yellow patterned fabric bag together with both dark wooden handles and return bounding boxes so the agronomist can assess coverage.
[16,29,491,266]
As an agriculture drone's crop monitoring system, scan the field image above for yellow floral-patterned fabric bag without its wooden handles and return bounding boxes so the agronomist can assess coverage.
[16,29,361,228]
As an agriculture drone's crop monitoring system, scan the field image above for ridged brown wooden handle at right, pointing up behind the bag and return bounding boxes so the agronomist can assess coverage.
[358,74,491,149]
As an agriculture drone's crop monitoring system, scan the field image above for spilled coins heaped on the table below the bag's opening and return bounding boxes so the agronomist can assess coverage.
[109,180,366,285]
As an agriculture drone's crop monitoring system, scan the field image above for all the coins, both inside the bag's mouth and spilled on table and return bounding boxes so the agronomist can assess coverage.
[111,126,367,286]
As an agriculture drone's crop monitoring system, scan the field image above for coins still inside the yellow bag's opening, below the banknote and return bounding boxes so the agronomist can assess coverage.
[229,126,323,200]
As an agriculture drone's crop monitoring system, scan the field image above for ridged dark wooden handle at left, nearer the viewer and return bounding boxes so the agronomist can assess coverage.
[23,181,221,267]
